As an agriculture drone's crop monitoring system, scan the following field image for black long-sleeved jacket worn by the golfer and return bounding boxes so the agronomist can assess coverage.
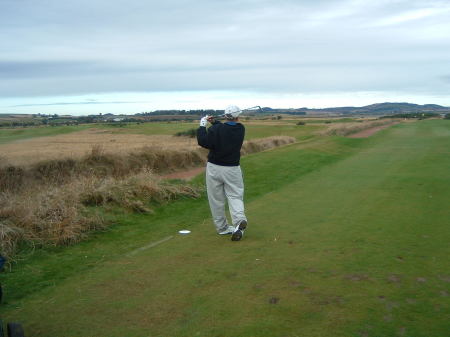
[197,121,245,166]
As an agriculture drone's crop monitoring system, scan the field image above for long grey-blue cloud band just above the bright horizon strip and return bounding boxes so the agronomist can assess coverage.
[0,62,448,96]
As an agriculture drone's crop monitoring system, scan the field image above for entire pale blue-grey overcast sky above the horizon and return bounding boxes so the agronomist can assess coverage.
[0,0,450,114]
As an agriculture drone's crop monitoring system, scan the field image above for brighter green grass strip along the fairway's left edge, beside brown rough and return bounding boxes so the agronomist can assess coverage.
[0,133,350,299]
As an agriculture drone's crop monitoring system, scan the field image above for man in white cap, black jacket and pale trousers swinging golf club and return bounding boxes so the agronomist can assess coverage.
[197,105,247,241]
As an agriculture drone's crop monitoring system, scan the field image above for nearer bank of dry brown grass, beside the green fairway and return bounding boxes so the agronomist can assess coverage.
[0,171,199,257]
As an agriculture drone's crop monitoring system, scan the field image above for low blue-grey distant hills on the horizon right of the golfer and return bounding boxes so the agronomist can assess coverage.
[262,103,450,115]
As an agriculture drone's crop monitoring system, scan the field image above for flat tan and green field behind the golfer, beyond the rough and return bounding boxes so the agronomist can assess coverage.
[0,122,320,165]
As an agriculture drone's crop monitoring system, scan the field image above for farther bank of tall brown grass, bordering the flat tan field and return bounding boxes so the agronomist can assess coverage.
[0,146,206,192]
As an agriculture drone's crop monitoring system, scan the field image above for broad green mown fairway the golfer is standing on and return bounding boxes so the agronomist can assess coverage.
[0,120,450,337]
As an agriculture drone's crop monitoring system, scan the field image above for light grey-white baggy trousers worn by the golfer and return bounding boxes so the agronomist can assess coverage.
[206,162,247,232]
